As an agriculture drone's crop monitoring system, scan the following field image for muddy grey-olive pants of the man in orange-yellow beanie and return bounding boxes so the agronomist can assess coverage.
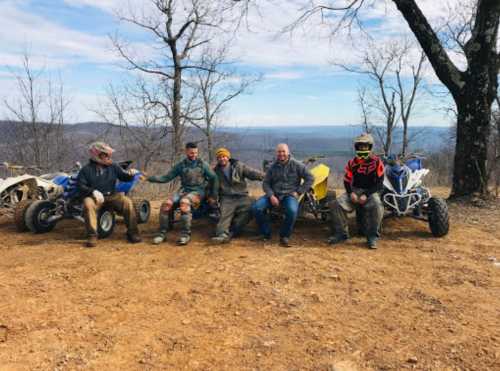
[215,196,253,236]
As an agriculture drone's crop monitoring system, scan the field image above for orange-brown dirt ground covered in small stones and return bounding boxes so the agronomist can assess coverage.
[0,190,500,371]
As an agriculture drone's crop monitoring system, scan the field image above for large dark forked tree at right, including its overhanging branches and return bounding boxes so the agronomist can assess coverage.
[235,0,500,198]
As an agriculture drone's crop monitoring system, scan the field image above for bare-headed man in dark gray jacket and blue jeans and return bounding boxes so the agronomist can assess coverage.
[253,143,314,247]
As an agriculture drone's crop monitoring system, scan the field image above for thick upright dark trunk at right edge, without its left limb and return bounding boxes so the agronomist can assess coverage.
[451,0,500,197]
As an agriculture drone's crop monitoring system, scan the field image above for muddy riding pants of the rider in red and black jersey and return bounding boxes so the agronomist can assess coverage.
[330,192,384,237]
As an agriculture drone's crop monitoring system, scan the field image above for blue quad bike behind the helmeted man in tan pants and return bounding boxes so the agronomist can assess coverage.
[19,161,151,238]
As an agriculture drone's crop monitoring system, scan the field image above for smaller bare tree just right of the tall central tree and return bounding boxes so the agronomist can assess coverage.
[191,44,259,162]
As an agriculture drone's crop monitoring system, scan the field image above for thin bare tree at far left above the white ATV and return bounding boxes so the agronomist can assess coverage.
[4,52,71,170]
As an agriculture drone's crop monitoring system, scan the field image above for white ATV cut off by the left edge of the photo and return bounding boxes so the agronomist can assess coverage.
[0,163,63,232]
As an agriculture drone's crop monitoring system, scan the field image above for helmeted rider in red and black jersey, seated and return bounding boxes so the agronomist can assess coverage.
[328,134,384,249]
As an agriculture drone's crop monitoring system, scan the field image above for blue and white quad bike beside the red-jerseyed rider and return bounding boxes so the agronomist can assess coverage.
[382,156,449,237]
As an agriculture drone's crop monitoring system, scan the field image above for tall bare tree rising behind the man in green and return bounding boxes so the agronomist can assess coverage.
[113,0,231,160]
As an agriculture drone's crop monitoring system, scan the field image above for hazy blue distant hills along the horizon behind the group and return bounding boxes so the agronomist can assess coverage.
[0,121,449,171]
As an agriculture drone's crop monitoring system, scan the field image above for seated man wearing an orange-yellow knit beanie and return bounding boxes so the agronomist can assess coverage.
[212,148,264,243]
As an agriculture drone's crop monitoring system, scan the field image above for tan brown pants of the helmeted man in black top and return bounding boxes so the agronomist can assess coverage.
[83,193,138,237]
